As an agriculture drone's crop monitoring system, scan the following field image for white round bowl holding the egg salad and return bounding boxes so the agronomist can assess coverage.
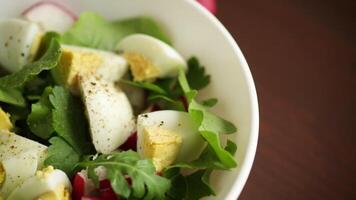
[0,0,259,200]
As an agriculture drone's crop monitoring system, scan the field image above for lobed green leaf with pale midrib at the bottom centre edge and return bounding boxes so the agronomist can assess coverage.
[78,151,170,200]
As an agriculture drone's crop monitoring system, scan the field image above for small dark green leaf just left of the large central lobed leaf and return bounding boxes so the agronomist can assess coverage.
[27,87,54,139]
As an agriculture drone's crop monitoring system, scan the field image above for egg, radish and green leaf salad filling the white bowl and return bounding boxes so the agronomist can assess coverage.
[0,2,237,200]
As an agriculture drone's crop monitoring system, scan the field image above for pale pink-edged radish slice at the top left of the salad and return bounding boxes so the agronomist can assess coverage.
[22,1,77,33]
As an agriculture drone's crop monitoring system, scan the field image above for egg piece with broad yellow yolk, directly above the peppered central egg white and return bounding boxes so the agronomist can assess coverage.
[53,45,128,93]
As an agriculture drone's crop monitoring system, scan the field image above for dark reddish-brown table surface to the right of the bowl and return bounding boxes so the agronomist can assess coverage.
[218,0,356,200]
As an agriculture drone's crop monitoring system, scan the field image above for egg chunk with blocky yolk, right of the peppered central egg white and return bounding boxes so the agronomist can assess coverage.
[137,110,205,170]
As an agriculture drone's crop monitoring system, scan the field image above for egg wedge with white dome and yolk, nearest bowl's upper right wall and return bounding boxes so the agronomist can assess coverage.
[116,34,187,81]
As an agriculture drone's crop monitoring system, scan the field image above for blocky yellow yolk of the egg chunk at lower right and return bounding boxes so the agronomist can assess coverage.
[142,127,182,172]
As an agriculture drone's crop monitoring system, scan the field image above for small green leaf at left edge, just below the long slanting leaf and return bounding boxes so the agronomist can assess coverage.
[0,86,26,107]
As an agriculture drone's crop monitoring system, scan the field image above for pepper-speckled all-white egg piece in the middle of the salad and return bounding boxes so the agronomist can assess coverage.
[79,76,135,153]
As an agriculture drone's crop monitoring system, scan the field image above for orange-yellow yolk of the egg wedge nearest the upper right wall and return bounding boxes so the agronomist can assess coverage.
[124,53,160,81]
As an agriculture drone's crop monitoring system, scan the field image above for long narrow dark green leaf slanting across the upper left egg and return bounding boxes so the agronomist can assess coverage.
[0,39,61,88]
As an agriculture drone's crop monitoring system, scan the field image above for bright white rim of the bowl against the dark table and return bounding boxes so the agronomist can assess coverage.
[184,0,259,200]
